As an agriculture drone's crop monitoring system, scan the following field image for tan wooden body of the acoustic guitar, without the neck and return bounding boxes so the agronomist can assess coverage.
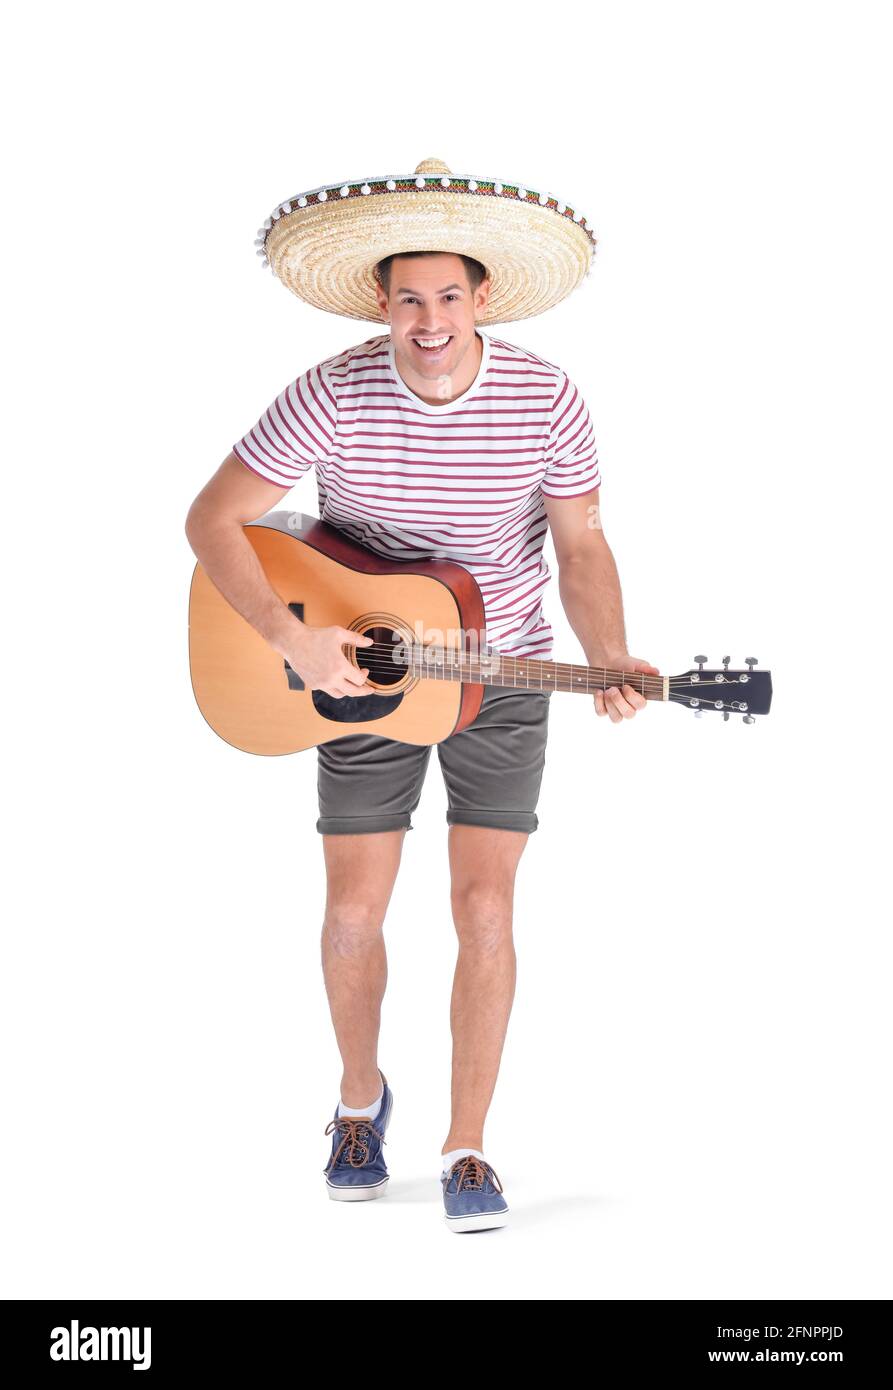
[189,512,484,755]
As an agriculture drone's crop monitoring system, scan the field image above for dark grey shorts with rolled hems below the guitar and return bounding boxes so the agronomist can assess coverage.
[316,685,551,835]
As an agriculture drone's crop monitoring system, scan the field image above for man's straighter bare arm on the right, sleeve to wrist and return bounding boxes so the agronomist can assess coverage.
[542,488,629,666]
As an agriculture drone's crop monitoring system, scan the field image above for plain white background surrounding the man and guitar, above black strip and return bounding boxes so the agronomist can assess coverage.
[0,0,893,1301]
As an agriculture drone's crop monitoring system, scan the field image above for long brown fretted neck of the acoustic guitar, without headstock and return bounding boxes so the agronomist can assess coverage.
[400,646,669,701]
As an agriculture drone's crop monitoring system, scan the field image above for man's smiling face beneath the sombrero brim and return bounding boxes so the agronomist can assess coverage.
[376,253,490,399]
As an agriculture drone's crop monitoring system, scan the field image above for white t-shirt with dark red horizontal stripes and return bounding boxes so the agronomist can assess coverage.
[232,327,601,657]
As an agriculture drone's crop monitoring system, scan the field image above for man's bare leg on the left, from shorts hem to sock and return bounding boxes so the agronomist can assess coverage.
[321,830,406,1109]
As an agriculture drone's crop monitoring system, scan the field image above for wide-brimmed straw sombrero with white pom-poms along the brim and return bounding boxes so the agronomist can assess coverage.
[255,160,595,324]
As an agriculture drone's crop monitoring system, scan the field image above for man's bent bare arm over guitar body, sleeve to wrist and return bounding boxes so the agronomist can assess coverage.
[186,453,306,656]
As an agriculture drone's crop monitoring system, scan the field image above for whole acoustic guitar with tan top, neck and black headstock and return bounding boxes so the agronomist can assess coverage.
[183,512,772,755]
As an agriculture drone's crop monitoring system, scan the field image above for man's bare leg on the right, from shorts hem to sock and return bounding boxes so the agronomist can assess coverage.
[439,826,529,1154]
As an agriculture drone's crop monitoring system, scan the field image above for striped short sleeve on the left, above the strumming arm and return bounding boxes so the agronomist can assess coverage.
[232,363,338,488]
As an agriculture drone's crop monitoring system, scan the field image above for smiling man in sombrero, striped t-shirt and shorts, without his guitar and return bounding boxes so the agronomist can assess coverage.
[186,161,657,1232]
